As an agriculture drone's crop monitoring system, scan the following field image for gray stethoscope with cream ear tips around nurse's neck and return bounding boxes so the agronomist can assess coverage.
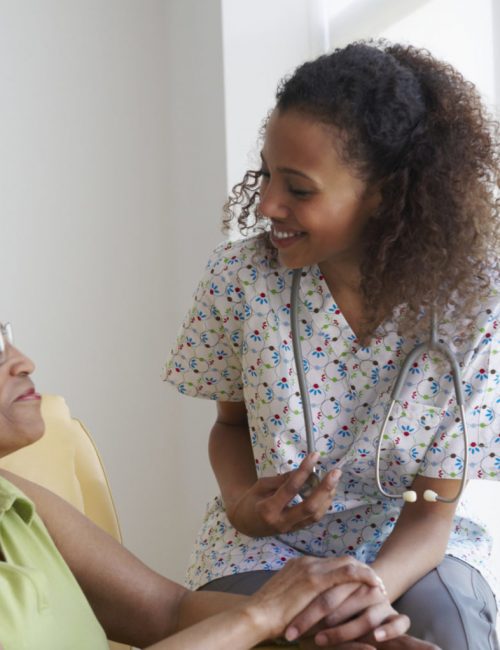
[290,269,469,503]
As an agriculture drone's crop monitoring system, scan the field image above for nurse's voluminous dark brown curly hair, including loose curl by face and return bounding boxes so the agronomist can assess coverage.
[224,41,500,336]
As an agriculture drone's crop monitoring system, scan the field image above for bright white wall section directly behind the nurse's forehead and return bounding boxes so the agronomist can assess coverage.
[222,0,326,189]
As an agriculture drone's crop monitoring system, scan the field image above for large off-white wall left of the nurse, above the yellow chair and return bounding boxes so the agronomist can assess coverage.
[0,0,226,578]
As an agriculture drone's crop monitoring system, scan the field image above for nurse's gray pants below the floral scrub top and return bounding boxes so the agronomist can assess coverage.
[200,555,499,650]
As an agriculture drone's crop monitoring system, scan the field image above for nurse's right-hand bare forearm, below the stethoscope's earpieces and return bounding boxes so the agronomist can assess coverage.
[372,476,460,602]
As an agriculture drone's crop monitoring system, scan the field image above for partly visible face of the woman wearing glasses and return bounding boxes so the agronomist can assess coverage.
[0,326,44,456]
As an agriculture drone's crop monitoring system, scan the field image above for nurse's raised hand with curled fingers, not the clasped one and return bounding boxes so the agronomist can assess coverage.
[226,452,341,537]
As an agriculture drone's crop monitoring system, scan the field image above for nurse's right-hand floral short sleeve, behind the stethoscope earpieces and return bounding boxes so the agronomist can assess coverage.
[420,296,500,480]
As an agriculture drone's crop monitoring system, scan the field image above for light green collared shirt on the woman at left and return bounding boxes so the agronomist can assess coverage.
[0,476,109,650]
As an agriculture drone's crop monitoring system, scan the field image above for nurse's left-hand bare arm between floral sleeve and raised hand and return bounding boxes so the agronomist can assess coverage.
[208,421,257,507]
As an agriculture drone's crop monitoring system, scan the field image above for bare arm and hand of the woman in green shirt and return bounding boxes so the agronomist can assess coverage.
[9,475,407,650]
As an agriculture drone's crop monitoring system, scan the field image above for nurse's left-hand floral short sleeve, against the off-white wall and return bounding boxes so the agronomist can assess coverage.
[164,243,243,402]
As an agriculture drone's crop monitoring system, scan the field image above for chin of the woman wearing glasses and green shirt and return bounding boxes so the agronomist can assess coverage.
[0,400,45,457]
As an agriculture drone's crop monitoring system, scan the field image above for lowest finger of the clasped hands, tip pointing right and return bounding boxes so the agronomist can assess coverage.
[315,603,410,646]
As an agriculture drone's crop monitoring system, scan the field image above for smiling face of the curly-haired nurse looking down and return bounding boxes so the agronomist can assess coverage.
[259,110,380,274]
